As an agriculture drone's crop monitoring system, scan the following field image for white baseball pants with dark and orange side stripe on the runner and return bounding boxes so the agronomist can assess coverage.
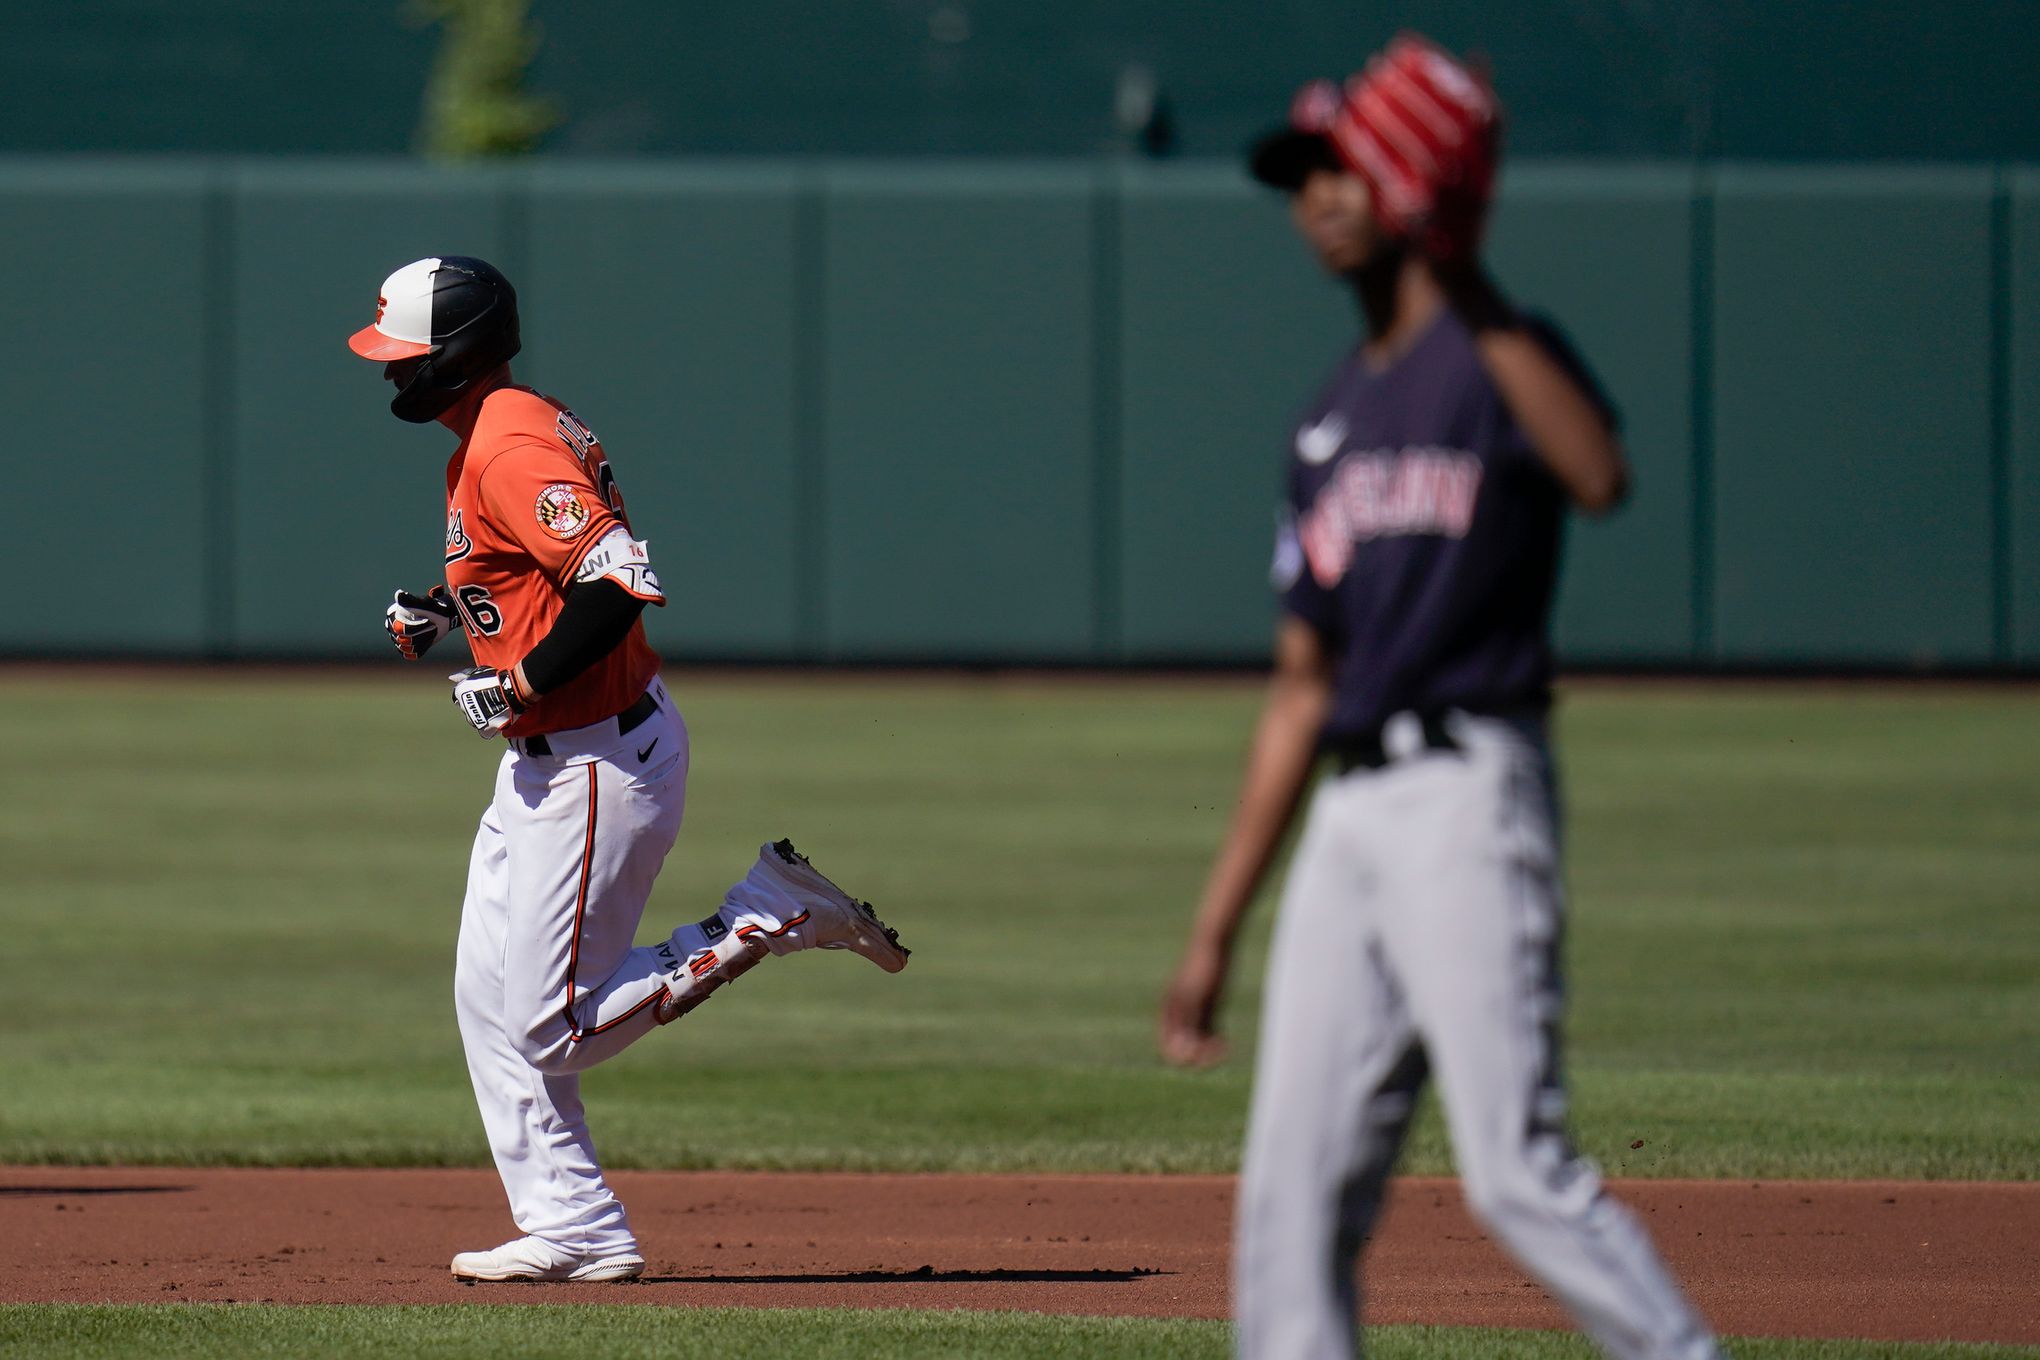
[455,679,820,1256]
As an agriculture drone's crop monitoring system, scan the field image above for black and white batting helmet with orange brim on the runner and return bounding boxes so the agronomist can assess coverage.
[347,255,522,424]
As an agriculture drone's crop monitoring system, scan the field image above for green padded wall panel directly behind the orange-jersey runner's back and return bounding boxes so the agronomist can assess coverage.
[520,167,818,661]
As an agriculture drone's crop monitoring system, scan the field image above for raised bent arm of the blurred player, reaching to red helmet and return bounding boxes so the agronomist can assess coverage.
[1432,265,1630,514]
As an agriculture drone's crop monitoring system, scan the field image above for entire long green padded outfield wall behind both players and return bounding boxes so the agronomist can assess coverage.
[0,161,2040,669]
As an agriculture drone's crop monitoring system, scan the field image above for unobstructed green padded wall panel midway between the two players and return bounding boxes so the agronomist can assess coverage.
[820,167,1098,661]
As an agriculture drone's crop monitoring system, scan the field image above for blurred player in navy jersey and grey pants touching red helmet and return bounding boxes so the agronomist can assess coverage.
[1161,37,1720,1360]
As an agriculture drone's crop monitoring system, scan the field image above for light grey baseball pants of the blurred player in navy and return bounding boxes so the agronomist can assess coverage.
[1234,714,1718,1360]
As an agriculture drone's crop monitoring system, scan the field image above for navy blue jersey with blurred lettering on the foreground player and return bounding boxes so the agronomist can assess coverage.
[1275,310,1599,744]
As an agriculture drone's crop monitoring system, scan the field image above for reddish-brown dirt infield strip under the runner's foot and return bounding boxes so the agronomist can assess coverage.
[0,1166,2040,1342]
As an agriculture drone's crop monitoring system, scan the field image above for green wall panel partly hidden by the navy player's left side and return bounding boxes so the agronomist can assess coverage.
[1114,167,1359,661]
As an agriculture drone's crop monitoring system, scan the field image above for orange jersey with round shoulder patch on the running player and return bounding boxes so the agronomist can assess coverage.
[447,387,665,736]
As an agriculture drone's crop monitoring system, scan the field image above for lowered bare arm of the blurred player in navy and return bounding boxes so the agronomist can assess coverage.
[1161,616,1332,1066]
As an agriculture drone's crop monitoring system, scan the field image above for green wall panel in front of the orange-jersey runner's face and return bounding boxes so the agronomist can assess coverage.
[226,165,505,657]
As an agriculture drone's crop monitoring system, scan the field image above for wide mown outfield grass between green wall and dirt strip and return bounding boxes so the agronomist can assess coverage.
[0,671,2040,1179]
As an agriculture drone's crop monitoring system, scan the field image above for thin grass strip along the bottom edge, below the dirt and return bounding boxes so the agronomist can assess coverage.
[0,1305,2040,1360]
